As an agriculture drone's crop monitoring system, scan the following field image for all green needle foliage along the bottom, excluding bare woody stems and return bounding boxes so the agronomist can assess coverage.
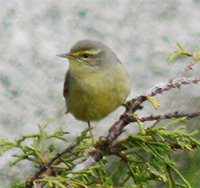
[0,118,200,188]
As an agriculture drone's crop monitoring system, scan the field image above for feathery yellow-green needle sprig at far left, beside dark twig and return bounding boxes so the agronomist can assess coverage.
[0,122,68,166]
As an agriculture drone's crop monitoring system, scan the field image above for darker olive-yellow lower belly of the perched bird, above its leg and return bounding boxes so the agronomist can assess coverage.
[66,84,126,121]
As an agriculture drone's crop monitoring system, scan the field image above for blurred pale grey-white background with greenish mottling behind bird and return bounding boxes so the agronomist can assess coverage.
[0,0,200,187]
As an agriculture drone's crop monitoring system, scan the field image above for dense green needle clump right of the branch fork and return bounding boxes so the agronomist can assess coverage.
[119,118,200,187]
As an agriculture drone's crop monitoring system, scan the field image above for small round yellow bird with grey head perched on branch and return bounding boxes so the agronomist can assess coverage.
[57,40,130,140]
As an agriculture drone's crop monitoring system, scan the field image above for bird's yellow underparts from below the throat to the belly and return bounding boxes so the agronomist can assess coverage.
[66,64,129,121]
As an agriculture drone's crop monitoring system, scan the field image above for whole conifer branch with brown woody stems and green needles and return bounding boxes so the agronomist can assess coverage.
[0,43,200,188]
